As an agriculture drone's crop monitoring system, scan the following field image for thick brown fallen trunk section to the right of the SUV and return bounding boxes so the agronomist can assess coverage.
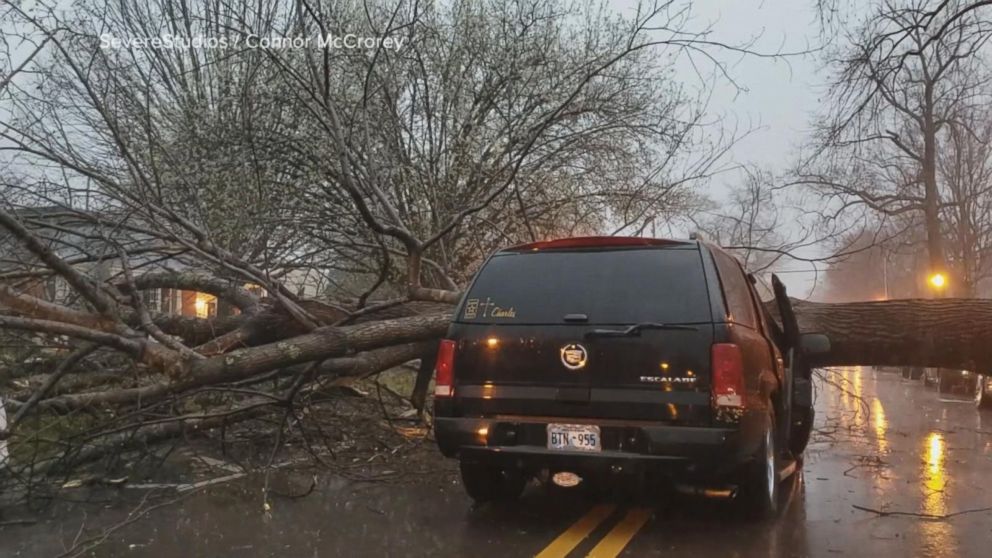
[788,299,992,371]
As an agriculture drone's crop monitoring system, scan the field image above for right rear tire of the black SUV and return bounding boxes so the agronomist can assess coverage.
[737,413,779,519]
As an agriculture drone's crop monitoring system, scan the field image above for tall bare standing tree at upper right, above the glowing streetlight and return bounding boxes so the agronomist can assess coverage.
[796,1,992,284]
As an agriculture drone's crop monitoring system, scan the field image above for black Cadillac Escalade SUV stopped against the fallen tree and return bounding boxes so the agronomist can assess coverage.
[434,237,826,514]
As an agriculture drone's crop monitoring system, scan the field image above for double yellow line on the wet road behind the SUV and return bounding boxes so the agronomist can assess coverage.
[537,504,651,558]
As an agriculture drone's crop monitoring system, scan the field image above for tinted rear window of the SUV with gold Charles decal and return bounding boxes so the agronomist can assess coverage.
[457,248,712,324]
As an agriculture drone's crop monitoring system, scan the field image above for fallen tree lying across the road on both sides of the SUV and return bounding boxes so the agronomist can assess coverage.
[7,284,992,437]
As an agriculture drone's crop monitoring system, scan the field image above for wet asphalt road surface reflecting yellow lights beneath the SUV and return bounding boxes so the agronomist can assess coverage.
[0,368,992,558]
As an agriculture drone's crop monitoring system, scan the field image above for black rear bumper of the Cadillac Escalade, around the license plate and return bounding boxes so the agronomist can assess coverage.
[434,417,760,476]
